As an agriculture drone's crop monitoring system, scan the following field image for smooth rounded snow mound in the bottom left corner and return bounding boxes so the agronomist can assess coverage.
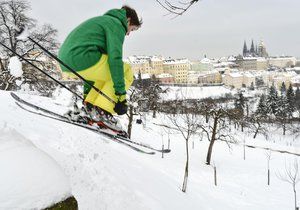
[0,128,71,209]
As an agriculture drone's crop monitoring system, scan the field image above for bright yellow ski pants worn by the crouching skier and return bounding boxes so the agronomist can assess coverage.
[64,54,133,114]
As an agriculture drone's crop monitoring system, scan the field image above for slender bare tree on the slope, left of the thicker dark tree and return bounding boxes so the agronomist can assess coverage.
[168,112,200,192]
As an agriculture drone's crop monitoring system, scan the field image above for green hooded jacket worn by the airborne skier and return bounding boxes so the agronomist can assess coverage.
[58,9,127,94]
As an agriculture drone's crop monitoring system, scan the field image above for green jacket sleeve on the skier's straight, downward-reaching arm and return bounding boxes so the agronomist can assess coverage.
[106,24,126,95]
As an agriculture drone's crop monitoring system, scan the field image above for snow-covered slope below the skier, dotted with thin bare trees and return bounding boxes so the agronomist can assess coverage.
[0,91,298,210]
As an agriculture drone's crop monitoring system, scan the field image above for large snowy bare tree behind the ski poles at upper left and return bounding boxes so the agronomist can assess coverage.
[0,0,58,90]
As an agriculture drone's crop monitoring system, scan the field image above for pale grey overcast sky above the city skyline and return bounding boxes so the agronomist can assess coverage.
[29,0,300,60]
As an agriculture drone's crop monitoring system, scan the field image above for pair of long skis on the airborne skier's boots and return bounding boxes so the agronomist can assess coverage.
[11,93,171,154]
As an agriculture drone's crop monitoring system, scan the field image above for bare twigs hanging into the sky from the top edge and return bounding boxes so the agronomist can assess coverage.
[156,0,199,16]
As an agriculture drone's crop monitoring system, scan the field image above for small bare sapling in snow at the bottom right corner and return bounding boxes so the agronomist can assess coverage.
[278,159,300,210]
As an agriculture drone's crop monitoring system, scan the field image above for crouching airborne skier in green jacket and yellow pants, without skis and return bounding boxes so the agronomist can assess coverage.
[58,6,142,128]
